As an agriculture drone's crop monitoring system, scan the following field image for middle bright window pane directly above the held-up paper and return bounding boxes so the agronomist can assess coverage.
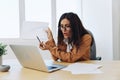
[25,0,51,23]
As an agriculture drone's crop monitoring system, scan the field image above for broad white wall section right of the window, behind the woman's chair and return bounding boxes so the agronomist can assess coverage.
[82,0,113,60]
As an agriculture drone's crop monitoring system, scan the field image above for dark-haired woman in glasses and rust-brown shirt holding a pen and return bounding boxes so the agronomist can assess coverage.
[39,12,92,62]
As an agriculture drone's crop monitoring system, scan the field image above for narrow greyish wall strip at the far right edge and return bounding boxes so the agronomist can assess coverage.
[112,0,120,60]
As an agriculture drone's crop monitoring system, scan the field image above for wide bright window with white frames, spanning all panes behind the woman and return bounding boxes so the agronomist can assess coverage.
[0,0,81,38]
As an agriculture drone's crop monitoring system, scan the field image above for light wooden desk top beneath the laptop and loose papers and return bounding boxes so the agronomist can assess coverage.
[0,60,120,80]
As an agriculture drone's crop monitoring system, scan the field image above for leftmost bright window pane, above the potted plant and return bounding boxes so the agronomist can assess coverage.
[0,0,19,38]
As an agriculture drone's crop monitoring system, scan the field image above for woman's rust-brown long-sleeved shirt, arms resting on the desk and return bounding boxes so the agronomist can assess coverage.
[49,34,91,62]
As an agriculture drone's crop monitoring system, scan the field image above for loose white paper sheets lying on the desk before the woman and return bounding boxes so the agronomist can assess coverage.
[62,63,102,74]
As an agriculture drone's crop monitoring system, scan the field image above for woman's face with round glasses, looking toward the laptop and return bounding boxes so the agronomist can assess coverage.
[60,18,72,38]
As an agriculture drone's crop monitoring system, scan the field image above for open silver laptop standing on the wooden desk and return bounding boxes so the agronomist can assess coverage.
[10,45,65,72]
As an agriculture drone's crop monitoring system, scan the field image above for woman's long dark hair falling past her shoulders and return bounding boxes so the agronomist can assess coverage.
[57,12,88,46]
